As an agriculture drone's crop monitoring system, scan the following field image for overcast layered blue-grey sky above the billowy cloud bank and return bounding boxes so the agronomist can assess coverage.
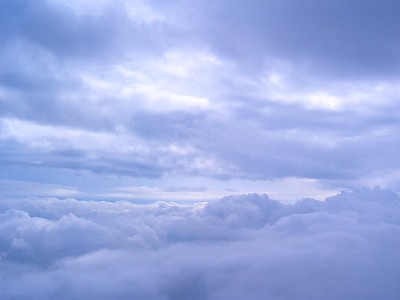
[0,0,400,200]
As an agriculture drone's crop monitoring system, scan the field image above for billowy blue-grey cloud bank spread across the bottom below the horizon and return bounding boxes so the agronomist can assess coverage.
[0,188,400,300]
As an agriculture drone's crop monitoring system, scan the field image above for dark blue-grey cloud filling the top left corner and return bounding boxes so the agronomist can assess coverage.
[0,1,166,63]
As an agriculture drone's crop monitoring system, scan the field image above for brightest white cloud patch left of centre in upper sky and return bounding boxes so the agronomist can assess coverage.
[80,49,222,115]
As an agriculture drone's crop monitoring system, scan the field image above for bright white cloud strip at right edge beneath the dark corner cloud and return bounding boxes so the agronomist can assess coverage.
[255,67,399,112]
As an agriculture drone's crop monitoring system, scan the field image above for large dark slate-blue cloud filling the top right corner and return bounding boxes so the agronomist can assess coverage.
[199,0,400,78]
